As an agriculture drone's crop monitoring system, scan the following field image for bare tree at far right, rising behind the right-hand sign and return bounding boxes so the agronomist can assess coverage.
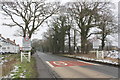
[97,10,117,50]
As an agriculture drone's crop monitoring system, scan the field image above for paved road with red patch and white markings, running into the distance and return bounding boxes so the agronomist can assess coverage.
[36,52,118,78]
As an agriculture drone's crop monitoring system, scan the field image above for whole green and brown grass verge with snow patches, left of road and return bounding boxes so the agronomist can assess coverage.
[3,54,37,78]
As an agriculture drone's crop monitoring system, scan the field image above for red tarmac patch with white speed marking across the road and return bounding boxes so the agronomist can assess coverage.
[49,61,92,67]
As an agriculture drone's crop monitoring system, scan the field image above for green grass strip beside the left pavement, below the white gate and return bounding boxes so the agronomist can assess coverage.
[13,57,37,78]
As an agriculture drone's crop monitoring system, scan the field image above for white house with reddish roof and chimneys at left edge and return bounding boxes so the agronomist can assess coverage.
[0,34,20,53]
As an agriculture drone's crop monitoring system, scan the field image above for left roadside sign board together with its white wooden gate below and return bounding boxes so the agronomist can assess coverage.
[21,37,31,62]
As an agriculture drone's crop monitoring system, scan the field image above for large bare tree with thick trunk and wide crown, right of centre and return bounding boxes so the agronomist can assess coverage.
[68,1,109,53]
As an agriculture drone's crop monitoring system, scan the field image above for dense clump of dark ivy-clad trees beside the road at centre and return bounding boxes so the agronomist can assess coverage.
[44,15,71,53]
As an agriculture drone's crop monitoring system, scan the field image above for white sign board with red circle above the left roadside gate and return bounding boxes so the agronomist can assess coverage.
[22,37,31,51]
